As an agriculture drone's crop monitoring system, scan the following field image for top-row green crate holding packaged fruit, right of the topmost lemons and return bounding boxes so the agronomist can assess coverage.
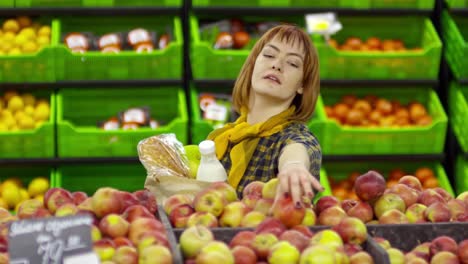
[52,16,183,80]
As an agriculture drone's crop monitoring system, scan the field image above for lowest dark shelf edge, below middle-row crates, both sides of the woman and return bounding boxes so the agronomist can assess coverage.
[0,154,445,165]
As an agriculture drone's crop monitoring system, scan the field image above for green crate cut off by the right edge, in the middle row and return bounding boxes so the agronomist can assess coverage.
[449,83,468,152]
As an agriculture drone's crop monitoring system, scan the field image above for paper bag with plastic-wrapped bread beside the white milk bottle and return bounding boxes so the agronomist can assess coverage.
[137,133,209,204]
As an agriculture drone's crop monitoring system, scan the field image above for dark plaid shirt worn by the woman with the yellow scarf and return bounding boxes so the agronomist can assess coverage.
[221,122,322,197]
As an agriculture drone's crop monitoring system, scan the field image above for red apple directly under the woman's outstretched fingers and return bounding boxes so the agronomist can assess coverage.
[273,196,305,228]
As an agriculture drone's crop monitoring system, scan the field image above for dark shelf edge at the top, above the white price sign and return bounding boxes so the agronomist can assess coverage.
[192,6,432,16]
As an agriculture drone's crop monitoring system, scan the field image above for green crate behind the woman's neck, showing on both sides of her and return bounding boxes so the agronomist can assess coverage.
[190,86,326,144]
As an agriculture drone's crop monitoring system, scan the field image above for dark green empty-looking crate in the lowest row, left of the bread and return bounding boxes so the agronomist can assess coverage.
[54,163,146,196]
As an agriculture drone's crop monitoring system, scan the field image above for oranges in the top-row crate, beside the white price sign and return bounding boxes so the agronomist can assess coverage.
[328,37,421,52]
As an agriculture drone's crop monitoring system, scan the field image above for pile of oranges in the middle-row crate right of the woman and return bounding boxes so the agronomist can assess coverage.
[325,95,432,127]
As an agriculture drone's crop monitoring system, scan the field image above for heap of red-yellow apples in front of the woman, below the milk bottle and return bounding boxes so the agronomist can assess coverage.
[163,178,316,228]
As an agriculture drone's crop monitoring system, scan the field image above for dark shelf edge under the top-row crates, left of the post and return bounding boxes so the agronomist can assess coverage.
[0,79,183,89]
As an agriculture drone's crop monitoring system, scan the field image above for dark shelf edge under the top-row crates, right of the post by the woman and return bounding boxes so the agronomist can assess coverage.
[194,79,439,88]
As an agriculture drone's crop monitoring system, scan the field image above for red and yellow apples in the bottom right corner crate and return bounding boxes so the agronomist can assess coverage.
[374,236,468,264]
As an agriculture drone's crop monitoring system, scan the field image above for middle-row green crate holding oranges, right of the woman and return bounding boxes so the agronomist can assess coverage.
[321,87,448,155]
